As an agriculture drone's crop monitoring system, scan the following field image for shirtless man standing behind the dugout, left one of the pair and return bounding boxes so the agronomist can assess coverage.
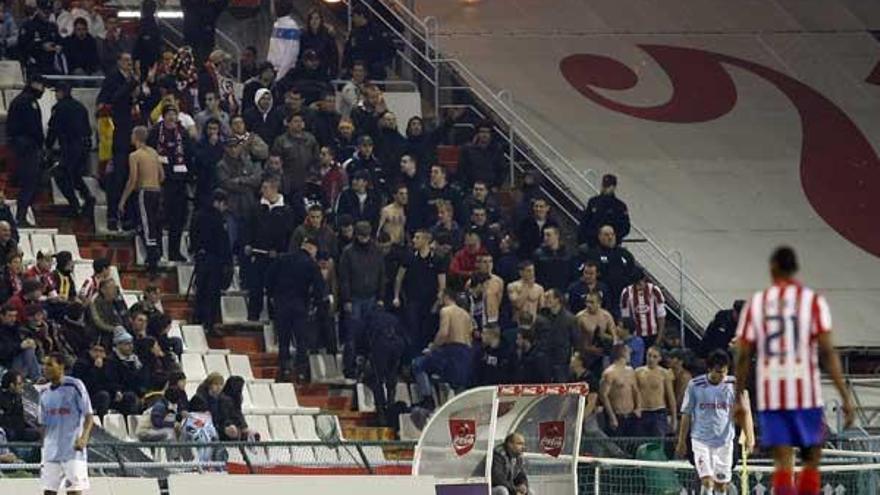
[599,344,642,437]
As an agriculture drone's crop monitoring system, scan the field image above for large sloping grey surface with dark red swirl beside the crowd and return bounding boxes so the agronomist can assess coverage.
[416,0,880,345]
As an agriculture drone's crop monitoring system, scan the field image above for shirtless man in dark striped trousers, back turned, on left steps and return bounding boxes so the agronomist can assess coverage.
[118,126,165,274]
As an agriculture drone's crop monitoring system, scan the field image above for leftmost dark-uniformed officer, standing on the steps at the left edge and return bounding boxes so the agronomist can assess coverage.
[6,74,45,227]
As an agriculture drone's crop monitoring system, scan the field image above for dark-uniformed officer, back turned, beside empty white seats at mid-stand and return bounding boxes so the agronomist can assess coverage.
[267,237,327,380]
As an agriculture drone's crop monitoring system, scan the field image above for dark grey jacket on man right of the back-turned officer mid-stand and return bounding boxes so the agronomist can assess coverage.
[339,242,385,303]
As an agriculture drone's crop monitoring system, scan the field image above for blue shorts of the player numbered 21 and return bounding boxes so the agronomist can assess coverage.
[758,407,825,448]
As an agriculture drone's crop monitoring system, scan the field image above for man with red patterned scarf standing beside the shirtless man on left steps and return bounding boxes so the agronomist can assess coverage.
[147,105,193,261]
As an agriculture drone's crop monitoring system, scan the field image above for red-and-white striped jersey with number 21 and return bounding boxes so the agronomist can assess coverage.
[736,280,831,411]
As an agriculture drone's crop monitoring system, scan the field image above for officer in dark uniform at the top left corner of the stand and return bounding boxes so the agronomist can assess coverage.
[18,0,61,74]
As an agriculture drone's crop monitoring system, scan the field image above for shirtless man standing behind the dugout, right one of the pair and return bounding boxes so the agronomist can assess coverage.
[636,346,676,437]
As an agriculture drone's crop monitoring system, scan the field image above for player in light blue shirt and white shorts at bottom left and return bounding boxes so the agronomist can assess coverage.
[40,353,93,495]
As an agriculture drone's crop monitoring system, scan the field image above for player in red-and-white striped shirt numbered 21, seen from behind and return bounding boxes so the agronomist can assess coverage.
[736,247,853,495]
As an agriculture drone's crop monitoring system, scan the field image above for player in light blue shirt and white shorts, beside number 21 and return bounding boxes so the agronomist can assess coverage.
[675,349,754,495]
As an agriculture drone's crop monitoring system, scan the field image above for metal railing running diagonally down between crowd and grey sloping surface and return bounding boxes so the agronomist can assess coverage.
[347,0,723,334]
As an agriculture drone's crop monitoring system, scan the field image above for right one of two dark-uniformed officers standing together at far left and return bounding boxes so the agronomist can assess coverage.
[46,81,95,216]
